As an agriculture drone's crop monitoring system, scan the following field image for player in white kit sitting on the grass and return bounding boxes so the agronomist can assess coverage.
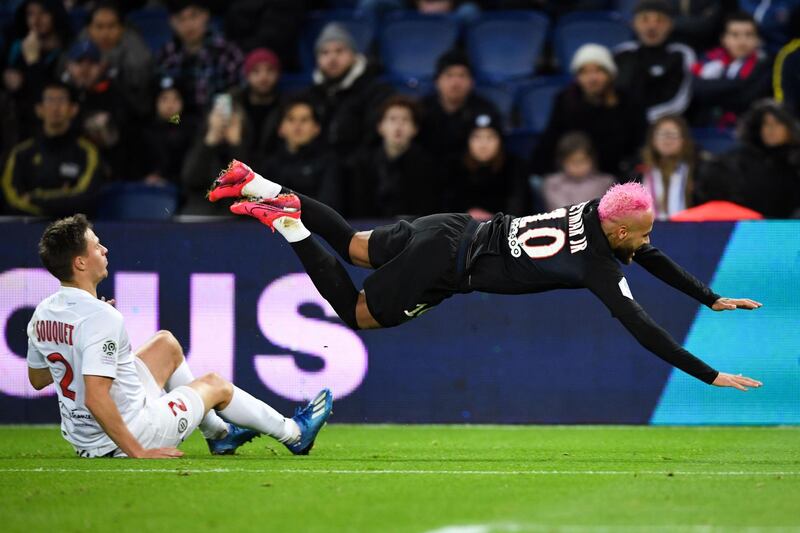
[28,215,333,459]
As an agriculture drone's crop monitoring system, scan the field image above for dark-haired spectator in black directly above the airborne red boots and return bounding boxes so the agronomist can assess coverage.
[262,98,343,210]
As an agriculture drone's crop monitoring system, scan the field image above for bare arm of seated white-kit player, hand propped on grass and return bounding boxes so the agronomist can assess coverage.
[83,375,183,459]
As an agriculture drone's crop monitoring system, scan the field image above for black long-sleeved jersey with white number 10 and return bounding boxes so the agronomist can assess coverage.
[466,200,719,383]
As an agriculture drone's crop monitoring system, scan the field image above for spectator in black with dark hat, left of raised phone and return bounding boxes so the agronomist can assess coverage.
[142,78,196,185]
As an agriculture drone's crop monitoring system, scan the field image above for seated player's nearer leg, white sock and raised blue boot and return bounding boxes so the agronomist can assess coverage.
[189,373,333,455]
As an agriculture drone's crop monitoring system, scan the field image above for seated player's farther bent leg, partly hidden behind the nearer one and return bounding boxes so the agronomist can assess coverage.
[136,331,253,455]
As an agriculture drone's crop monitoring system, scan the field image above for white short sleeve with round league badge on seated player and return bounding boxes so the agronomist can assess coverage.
[79,311,123,378]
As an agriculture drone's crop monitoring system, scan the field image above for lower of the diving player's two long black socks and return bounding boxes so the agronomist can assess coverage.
[291,236,358,329]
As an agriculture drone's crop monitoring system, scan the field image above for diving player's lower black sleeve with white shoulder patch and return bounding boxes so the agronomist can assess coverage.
[587,260,718,384]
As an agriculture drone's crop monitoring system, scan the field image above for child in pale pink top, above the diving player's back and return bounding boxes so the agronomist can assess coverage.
[542,132,616,211]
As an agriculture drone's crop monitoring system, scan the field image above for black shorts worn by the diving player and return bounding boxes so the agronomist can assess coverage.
[364,214,478,327]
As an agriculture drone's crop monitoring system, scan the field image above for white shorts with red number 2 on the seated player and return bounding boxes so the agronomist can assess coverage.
[129,357,205,454]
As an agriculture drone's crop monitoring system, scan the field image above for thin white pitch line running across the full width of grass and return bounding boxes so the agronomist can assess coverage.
[0,467,800,477]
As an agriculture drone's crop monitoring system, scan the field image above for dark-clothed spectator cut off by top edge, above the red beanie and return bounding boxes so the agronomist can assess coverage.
[225,0,313,71]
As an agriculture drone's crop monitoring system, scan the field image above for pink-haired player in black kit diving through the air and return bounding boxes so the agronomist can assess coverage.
[209,160,761,390]
